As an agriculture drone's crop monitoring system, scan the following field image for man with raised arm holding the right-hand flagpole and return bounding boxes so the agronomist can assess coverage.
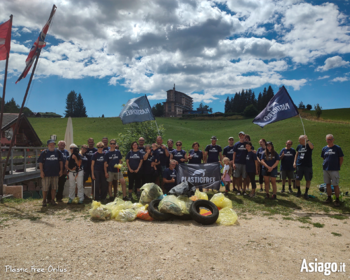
[293,135,314,199]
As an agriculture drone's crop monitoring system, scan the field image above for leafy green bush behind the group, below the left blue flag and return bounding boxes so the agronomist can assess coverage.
[117,121,165,155]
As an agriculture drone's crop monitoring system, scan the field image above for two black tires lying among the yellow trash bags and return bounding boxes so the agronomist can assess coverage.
[148,199,219,225]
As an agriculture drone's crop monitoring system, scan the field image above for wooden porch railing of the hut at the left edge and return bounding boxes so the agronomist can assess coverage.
[1,147,45,185]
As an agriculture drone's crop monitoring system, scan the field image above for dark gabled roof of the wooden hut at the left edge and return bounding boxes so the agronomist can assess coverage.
[0,113,42,147]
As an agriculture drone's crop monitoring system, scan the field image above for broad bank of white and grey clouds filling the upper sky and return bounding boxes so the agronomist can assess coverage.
[0,0,350,102]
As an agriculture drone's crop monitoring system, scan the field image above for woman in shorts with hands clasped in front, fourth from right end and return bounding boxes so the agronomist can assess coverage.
[261,142,280,199]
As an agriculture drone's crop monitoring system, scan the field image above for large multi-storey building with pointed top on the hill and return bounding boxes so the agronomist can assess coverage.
[163,84,193,117]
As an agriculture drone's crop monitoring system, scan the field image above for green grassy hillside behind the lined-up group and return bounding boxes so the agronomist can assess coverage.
[29,115,350,186]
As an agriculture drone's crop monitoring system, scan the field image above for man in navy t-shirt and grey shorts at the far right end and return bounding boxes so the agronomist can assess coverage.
[321,134,344,207]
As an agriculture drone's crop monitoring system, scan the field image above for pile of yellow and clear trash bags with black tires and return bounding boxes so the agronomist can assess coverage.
[89,182,238,225]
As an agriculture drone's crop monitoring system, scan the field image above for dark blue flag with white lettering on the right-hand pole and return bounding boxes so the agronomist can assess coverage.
[253,86,299,127]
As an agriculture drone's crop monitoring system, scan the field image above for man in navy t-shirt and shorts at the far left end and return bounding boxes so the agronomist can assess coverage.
[38,140,63,206]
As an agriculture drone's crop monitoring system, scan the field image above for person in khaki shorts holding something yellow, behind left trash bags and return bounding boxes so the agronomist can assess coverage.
[104,139,128,201]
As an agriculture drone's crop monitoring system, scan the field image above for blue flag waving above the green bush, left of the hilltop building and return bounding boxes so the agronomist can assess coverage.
[119,95,154,124]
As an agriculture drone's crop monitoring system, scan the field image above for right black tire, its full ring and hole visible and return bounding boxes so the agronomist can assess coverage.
[190,199,219,225]
